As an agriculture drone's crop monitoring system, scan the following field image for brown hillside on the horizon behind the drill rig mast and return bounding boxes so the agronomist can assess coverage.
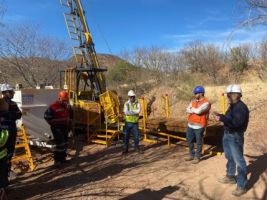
[0,54,127,87]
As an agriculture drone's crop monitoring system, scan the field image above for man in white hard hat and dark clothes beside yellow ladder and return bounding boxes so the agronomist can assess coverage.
[1,83,22,173]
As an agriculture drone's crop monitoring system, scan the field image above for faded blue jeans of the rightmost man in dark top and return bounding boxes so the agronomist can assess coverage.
[223,130,247,188]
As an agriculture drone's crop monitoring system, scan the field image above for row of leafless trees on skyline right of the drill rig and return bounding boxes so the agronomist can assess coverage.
[123,42,224,83]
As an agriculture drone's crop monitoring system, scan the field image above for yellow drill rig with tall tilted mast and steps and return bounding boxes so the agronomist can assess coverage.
[60,0,120,146]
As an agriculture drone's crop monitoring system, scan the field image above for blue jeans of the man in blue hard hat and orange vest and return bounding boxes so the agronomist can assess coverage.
[186,127,204,159]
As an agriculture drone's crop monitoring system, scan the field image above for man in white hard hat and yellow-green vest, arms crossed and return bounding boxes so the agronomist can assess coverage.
[123,90,143,154]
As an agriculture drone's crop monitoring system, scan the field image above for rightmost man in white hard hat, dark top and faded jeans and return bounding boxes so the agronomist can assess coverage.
[213,85,249,196]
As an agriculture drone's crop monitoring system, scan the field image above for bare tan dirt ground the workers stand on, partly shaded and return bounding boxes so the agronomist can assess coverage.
[7,80,267,200]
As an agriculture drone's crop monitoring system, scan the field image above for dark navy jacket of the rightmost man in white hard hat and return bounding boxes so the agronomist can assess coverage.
[219,101,249,132]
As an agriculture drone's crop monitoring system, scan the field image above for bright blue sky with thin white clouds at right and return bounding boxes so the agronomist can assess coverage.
[4,0,266,54]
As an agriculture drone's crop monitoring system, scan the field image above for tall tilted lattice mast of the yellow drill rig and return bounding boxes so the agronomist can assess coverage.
[60,0,106,100]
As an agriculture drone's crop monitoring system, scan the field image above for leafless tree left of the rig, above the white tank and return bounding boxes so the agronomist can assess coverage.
[0,25,70,87]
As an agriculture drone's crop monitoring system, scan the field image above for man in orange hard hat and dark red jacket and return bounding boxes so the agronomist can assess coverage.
[44,91,72,167]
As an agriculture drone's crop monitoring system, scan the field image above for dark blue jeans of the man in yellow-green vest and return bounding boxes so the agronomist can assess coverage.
[124,122,139,150]
